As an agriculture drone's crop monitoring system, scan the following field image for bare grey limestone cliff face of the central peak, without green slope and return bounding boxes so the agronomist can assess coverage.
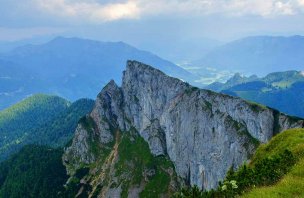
[64,61,304,192]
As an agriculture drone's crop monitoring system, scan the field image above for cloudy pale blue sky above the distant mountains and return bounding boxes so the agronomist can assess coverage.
[0,0,304,61]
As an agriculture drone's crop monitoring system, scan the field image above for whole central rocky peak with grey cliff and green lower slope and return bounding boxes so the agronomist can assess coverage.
[63,61,304,197]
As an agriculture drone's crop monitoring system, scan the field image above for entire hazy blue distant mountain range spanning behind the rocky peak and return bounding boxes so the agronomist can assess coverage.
[0,36,304,109]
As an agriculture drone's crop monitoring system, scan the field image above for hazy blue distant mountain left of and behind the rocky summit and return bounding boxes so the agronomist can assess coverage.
[0,37,194,109]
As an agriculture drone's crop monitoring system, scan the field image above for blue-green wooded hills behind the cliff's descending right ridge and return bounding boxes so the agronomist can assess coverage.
[206,71,304,117]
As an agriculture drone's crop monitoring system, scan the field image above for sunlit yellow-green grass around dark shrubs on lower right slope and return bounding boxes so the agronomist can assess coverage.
[242,129,304,198]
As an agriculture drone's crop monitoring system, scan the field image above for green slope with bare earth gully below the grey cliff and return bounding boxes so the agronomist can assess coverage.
[64,127,178,198]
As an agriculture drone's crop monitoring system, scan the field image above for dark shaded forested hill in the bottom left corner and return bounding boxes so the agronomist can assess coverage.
[0,145,68,198]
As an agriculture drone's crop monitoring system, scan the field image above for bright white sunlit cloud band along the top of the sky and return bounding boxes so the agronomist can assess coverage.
[33,0,304,23]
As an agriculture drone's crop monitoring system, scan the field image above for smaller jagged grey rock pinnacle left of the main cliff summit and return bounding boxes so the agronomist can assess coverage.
[63,81,124,172]
